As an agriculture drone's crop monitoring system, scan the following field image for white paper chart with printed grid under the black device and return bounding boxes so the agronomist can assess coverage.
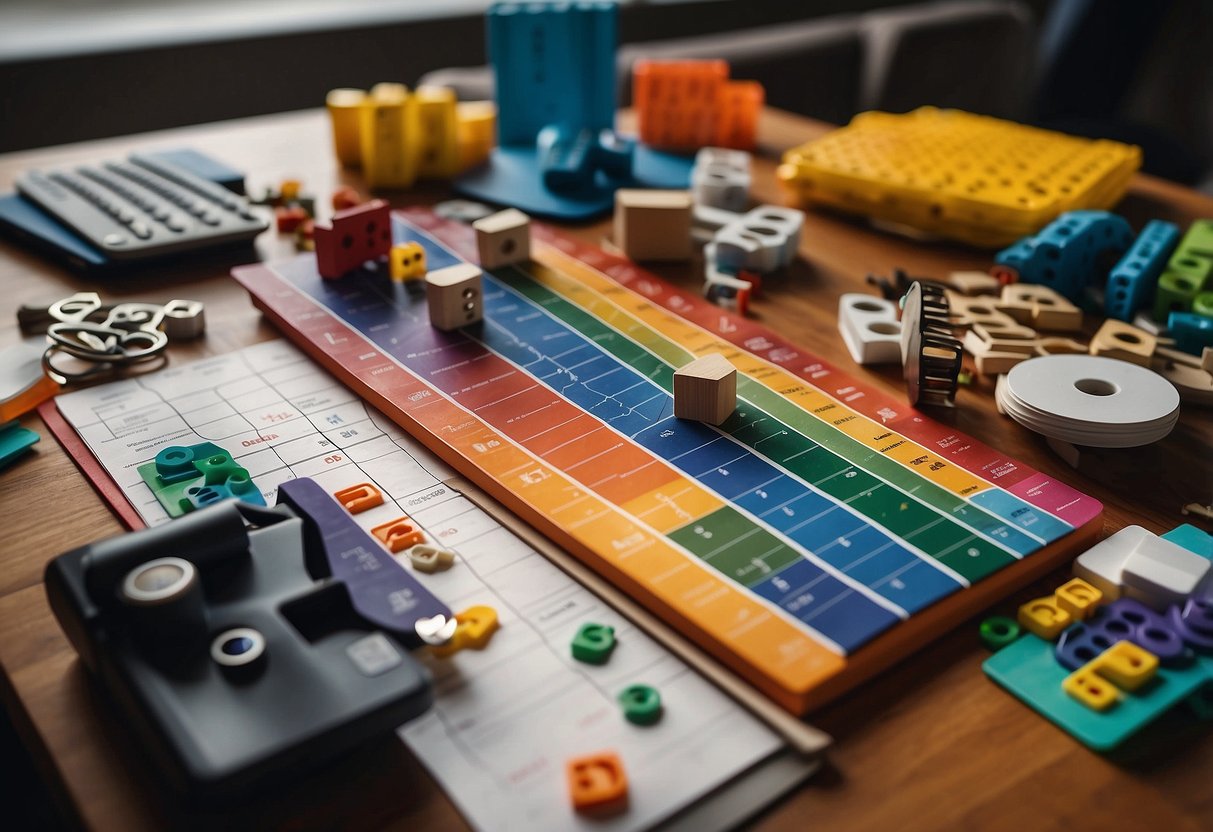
[56,341,782,832]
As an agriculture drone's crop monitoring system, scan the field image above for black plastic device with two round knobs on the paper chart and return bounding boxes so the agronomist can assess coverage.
[46,489,432,799]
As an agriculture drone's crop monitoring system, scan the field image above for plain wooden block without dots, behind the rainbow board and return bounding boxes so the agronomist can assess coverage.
[615,188,691,261]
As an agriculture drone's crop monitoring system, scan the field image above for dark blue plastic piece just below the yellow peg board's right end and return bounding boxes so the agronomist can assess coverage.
[995,211,1133,303]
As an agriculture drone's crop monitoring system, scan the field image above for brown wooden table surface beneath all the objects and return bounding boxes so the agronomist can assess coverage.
[0,112,1213,832]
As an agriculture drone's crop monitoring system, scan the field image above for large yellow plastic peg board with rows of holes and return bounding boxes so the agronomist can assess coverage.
[779,107,1141,247]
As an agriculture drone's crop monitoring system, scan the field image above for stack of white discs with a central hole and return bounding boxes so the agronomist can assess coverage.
[997,355,1179,448]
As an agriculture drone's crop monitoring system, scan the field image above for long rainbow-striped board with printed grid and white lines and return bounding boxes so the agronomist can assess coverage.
[233,204,1101,713]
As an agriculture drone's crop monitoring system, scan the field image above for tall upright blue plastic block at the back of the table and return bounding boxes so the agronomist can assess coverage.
[485,2,617,147]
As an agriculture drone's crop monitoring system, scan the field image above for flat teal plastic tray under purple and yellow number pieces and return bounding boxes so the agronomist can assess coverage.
[981,633,1213,751]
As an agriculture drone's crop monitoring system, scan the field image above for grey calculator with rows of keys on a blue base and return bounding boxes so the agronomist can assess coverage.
[17,153,269,261]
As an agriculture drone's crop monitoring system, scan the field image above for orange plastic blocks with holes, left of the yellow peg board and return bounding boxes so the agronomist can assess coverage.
[632,61,765,149]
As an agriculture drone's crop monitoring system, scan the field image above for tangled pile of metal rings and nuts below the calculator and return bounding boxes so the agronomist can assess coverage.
[18,292,205,383]
